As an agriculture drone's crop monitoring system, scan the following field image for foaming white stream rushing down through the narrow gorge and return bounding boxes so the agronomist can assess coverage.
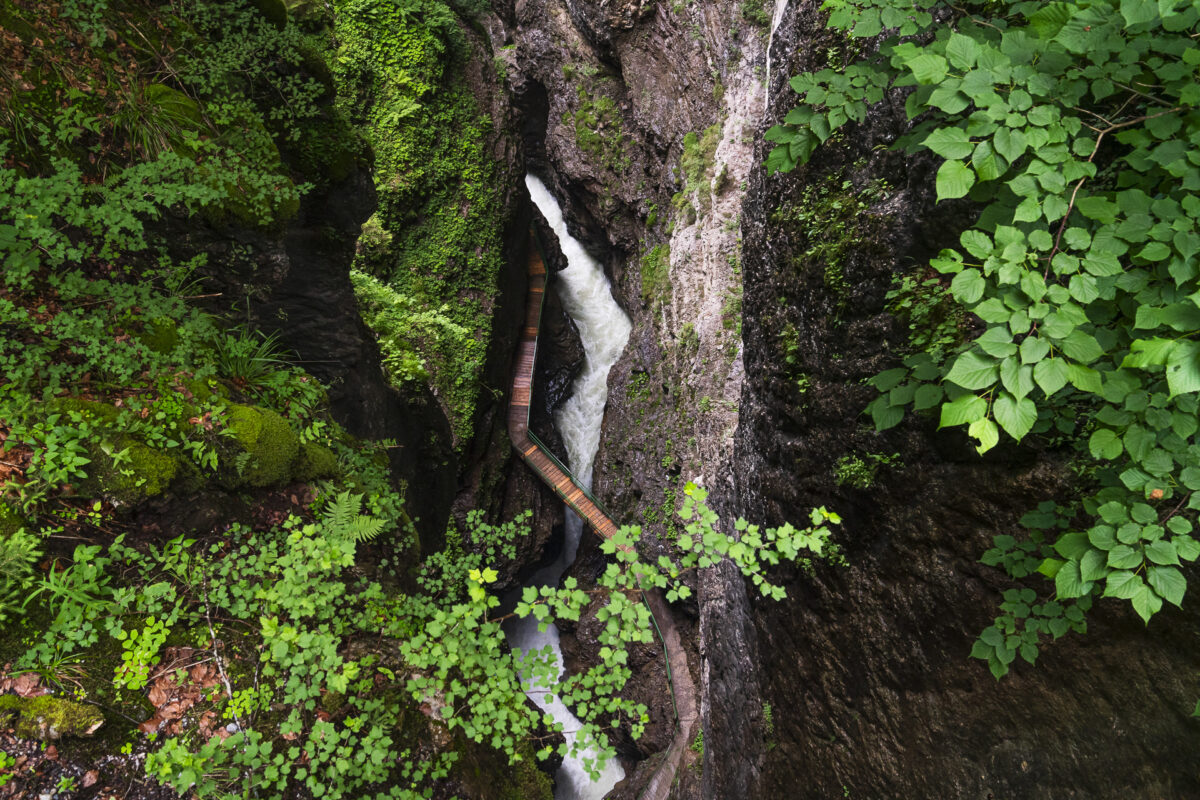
[506,175,631,800]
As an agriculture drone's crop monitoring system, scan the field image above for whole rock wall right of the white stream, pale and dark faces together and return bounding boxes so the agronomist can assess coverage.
[492,1,1192,798]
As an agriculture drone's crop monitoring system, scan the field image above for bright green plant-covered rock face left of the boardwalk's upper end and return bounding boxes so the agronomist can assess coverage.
[334,0,508,447]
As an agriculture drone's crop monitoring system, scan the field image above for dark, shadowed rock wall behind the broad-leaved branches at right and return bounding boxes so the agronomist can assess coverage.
[724,2,1200,799]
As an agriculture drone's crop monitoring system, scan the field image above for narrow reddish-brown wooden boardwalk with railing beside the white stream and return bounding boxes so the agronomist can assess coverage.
[508,233,700,800]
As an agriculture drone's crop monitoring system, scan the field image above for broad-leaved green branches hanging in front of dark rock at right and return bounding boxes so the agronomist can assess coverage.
[767,0,1200,678]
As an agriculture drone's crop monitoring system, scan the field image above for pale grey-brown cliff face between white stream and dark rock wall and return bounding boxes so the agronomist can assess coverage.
[492,0,782,796]
